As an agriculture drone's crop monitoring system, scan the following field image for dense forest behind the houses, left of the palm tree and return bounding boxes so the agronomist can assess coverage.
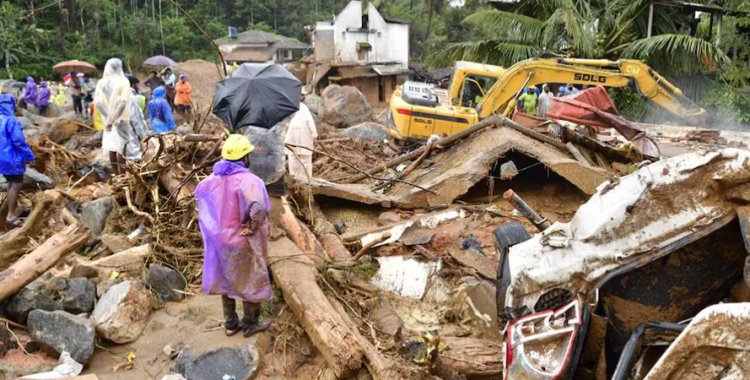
[0,0,487,77]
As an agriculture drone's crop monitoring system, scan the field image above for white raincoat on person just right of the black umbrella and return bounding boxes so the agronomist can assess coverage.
[284,103,318,180]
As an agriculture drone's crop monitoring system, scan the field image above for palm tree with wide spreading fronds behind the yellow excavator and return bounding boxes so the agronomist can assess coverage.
[433,0,728,73]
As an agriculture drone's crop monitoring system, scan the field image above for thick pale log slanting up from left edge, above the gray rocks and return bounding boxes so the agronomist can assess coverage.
[0,224,90,301]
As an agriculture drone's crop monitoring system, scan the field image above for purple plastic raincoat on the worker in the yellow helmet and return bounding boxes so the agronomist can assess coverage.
[195,160,273,303]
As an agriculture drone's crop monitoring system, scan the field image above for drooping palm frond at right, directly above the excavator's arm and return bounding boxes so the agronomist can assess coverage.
[623,34,729,74]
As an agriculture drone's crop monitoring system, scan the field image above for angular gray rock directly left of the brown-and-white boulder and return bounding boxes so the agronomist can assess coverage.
[26,310,96,363]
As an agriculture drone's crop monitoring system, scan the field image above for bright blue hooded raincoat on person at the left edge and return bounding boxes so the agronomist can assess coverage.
[0,94,34,175]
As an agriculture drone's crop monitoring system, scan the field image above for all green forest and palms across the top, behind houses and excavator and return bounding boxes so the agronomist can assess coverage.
[0,0,750,125]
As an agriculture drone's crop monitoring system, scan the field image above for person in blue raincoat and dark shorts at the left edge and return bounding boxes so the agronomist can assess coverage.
[0,94,34,228]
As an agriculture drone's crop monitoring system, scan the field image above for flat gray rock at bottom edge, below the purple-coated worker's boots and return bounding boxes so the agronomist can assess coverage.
[172,345,260,380]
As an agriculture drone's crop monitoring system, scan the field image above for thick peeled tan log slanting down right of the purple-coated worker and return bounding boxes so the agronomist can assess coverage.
[268,237,363,378]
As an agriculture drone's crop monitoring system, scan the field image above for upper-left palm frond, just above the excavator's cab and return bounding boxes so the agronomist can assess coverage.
[463,10,544,41]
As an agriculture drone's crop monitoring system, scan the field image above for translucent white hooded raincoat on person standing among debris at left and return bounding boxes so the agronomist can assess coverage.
[94,58,133,154]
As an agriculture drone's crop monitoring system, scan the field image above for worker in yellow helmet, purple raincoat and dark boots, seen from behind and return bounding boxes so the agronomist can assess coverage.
[195,134,273,337]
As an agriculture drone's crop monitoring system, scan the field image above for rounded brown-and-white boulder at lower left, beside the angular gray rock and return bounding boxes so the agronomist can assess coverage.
[92,281,151,343]
